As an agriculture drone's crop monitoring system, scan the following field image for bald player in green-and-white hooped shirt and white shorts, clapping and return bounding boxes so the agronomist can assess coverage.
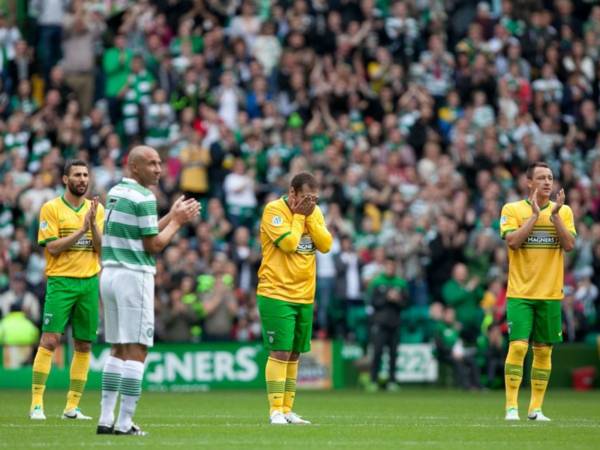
[97,146,200,436]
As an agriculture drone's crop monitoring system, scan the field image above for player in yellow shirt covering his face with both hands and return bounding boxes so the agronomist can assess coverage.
[257,172,333,425]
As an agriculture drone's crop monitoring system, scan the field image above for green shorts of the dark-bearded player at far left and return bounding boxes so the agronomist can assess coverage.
[42,275,99,341]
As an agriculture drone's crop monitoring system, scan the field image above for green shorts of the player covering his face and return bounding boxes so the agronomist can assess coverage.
[256,295,314,353]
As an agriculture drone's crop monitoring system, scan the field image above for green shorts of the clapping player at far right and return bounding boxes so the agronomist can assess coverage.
[506,298,562,344]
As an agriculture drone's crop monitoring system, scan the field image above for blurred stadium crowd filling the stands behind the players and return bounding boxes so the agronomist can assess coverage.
[0,0,600,386]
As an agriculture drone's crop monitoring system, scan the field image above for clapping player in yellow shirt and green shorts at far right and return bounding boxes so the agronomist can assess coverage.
[500,162,576,421]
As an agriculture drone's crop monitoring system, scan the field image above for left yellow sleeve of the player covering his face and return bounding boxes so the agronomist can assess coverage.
[262,204,306,253]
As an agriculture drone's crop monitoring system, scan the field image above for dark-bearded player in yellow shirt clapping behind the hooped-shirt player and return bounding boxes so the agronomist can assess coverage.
[29,160,104,420]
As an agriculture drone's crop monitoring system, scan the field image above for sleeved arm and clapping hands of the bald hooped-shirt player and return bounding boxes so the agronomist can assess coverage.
[139,198,200,253]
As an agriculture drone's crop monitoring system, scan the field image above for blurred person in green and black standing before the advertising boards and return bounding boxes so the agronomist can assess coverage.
[367,256,408,390]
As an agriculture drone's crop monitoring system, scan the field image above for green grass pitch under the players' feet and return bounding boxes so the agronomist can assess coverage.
[0,387,600,450]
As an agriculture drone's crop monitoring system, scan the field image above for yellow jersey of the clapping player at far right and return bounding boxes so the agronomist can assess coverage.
[500,200,576,300]
